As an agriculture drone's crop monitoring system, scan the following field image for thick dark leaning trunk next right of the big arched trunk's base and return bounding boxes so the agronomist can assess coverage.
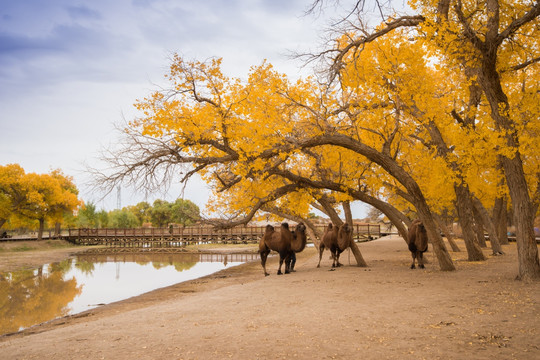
[454,184,486,261]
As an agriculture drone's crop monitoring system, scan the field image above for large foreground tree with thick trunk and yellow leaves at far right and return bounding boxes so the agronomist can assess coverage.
[308,0,540,279]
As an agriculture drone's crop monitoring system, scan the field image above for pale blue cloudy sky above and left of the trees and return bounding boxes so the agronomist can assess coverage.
[0,0,372,216]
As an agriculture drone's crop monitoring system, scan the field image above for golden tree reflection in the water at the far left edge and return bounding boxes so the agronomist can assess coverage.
[0,259,81,334]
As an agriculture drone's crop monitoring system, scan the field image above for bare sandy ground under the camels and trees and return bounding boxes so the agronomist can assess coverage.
[0,237,540,359]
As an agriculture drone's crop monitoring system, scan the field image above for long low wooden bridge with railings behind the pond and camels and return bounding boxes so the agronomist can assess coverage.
[62,224,381,250]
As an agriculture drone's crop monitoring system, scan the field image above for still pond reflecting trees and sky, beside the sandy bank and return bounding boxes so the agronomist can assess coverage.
[0,253,258,335]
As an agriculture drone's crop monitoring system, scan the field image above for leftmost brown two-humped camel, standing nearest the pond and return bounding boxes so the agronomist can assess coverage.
[259,223,293,276]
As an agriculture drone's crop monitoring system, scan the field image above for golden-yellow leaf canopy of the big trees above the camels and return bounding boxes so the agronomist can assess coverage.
[125,0,540,222]
